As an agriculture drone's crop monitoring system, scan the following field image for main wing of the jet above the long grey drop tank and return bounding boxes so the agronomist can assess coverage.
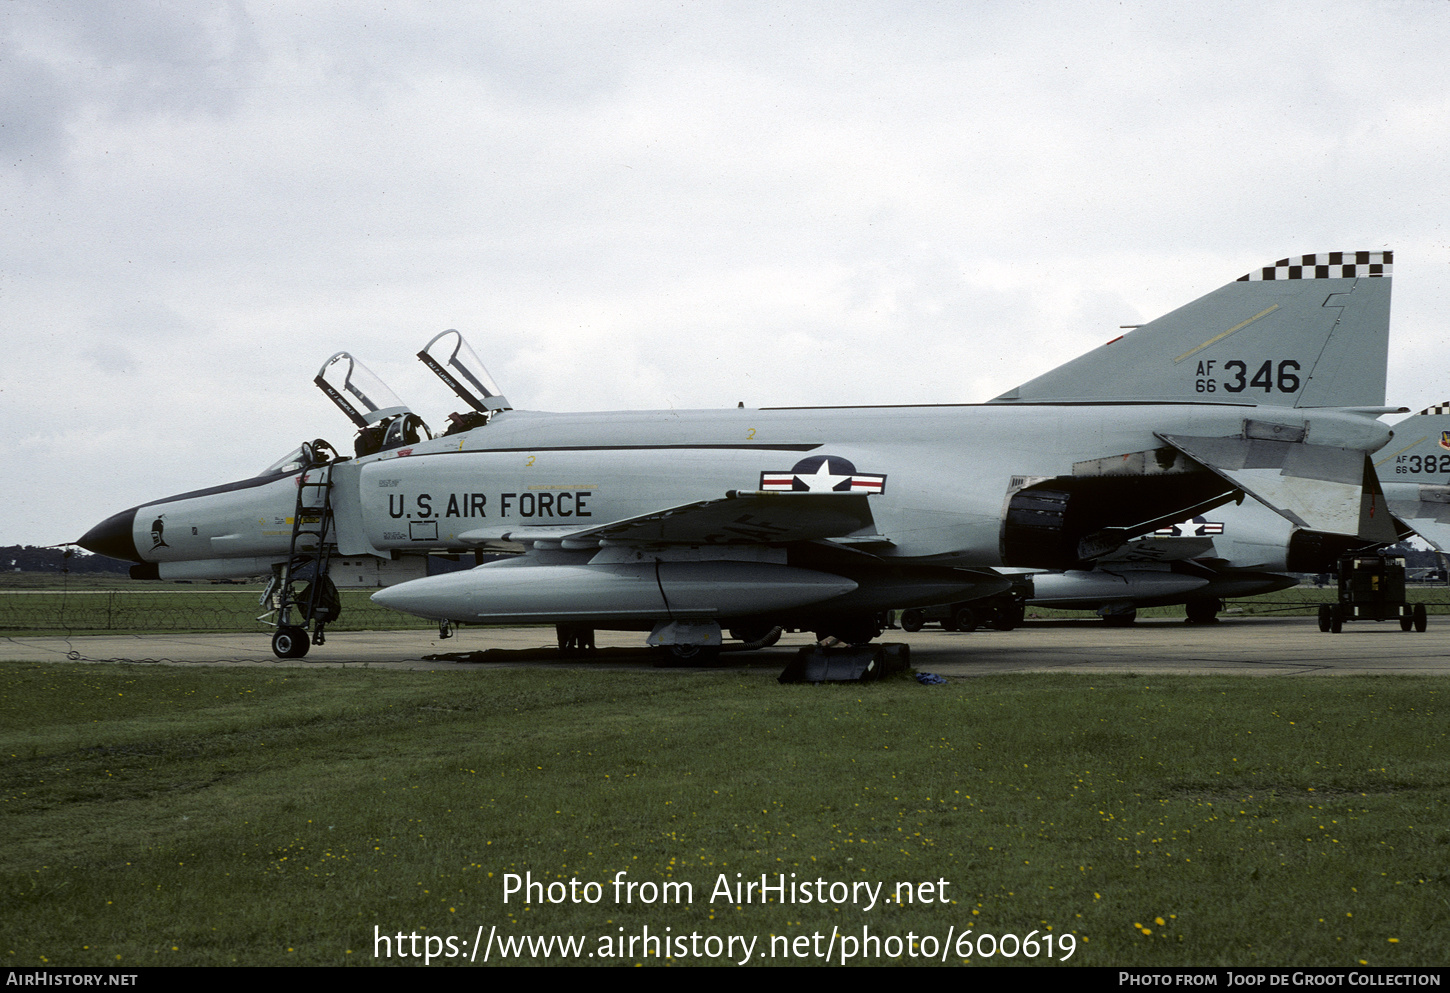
[460,490,882,548]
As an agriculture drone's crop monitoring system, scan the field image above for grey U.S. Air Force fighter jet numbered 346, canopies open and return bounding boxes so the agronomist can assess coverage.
[80,252,1393,657]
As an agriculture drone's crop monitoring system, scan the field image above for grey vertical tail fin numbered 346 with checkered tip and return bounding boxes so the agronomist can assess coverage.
[993,252,1393,407]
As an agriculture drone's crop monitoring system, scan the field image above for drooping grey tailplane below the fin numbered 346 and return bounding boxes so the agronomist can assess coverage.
[1159,432,1396,542]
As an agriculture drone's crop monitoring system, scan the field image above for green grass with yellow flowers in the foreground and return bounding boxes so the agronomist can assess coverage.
[0,662,1450,965]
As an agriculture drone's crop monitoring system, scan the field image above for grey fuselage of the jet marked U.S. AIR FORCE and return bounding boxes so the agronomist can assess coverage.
[83,403,1389,577]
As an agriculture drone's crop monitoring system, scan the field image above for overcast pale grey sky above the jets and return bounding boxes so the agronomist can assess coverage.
[0,0,1450,545]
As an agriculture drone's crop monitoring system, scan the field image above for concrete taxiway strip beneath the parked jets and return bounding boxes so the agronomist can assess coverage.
[0,616,1450,677]
